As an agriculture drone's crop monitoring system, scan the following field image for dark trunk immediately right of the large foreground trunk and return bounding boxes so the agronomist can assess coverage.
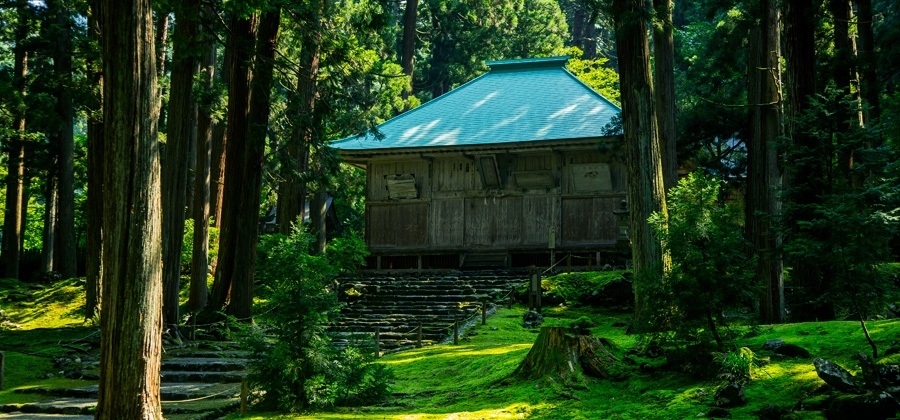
[162,0,205,337]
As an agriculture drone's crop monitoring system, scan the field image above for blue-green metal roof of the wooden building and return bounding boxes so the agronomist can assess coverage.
[331,57,621,151]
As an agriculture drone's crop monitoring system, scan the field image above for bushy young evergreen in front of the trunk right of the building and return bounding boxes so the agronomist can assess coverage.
[644,172,756,348]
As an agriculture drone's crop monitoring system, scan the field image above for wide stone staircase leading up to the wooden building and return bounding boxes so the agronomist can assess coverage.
[330,271,528,352]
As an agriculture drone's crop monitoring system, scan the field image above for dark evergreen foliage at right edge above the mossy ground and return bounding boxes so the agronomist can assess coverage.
[784,86,900,318]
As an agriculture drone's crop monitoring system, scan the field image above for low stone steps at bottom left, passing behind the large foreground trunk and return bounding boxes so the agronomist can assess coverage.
[0,342,247,420]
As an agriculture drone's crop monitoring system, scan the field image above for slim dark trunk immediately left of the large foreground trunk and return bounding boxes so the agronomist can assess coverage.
[84,0,103,319]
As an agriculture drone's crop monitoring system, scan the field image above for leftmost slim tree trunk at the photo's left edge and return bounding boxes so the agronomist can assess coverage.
[3,1,29,279]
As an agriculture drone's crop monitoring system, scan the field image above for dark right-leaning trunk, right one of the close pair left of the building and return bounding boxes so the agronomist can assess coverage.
[225,8,281,321]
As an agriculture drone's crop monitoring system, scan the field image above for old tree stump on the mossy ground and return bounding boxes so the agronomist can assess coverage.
[513,327,626,381]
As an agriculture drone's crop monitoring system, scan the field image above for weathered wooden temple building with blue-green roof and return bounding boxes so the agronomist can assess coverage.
[332,57,627,270]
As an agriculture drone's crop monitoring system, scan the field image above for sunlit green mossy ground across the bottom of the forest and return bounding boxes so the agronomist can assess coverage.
[0,280,900,420]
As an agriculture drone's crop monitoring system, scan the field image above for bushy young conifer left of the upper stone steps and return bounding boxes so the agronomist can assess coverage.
[245,230,392,411]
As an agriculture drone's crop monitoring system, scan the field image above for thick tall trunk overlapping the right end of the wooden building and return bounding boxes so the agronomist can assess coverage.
[613,0,670,325]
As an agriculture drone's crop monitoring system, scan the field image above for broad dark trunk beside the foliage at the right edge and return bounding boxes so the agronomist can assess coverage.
[784,0,835,321]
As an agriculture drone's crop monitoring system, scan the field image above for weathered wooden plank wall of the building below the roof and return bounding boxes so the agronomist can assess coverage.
[366,149,627,253]
